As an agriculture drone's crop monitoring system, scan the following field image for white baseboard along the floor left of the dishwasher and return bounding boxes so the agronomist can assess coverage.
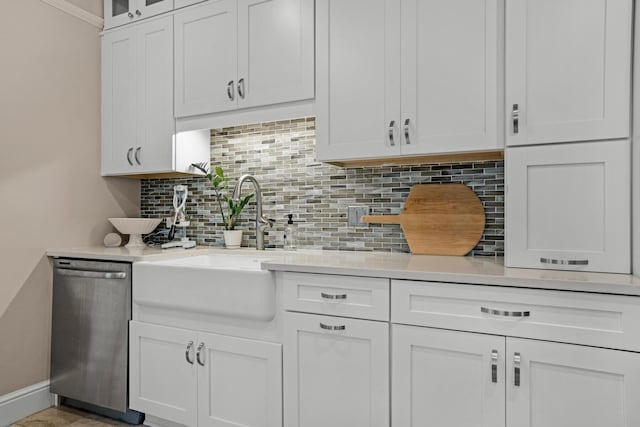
[0,381,53,426]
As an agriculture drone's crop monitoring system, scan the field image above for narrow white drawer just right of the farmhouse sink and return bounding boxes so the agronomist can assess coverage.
[283,273,389,320]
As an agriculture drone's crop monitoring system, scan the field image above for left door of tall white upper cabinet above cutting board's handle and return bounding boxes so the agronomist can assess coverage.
[316,0,401,160]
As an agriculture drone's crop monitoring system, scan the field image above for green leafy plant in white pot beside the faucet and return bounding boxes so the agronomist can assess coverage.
[193,164,253,249]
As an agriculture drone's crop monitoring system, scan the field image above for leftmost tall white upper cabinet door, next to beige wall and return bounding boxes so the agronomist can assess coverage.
[102,27,138,174]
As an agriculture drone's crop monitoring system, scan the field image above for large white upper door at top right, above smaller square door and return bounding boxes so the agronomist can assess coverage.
[506,0,633,145]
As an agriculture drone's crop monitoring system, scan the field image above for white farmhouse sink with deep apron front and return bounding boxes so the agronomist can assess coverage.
[133,252,276,321]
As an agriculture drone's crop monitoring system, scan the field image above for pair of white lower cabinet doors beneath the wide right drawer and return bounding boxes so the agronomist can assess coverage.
[391,325,640,427]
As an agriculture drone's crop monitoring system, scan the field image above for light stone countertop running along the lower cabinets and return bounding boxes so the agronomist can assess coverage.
[47,247,640,296]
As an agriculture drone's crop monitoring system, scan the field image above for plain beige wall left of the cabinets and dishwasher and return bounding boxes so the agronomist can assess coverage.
[0,0,140,396]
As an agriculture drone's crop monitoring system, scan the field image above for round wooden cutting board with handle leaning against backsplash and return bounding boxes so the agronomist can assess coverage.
[362,184,485,255]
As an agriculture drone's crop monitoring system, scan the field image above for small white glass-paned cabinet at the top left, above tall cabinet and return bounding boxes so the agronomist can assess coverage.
[104,0,173,29]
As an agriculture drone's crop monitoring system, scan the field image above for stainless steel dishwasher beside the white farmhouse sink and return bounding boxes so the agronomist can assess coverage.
[51,259,138,421]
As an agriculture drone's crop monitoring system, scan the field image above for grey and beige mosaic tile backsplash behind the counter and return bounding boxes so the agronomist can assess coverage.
[141,118,504,256]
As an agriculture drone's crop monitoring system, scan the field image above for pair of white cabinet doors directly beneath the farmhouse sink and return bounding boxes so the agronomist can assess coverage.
[129,321,282,427]
